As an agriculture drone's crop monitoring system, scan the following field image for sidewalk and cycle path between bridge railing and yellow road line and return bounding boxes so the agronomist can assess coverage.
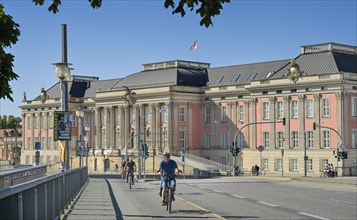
[61,176,220,220]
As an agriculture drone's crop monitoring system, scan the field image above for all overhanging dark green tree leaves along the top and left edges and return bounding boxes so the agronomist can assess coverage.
[0,0,230,101]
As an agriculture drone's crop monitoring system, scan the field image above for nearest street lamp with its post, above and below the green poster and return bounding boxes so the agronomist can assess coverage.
[54,62,71,170]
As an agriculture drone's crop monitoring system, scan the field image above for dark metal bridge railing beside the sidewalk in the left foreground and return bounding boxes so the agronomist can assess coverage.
[0,167,88,220]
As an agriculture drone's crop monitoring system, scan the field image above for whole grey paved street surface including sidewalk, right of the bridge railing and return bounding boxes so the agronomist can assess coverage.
[64,177,357,220]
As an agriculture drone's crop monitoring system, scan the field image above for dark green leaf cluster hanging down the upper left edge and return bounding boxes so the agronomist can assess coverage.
[0,4,20,101]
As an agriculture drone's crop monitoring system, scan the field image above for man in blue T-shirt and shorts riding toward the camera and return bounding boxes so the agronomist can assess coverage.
[159,152,180,206]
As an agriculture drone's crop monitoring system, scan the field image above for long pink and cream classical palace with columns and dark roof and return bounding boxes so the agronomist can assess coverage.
[21,43,357,176]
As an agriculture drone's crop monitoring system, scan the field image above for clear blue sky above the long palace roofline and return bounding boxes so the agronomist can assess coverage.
[0,0,357,117]
